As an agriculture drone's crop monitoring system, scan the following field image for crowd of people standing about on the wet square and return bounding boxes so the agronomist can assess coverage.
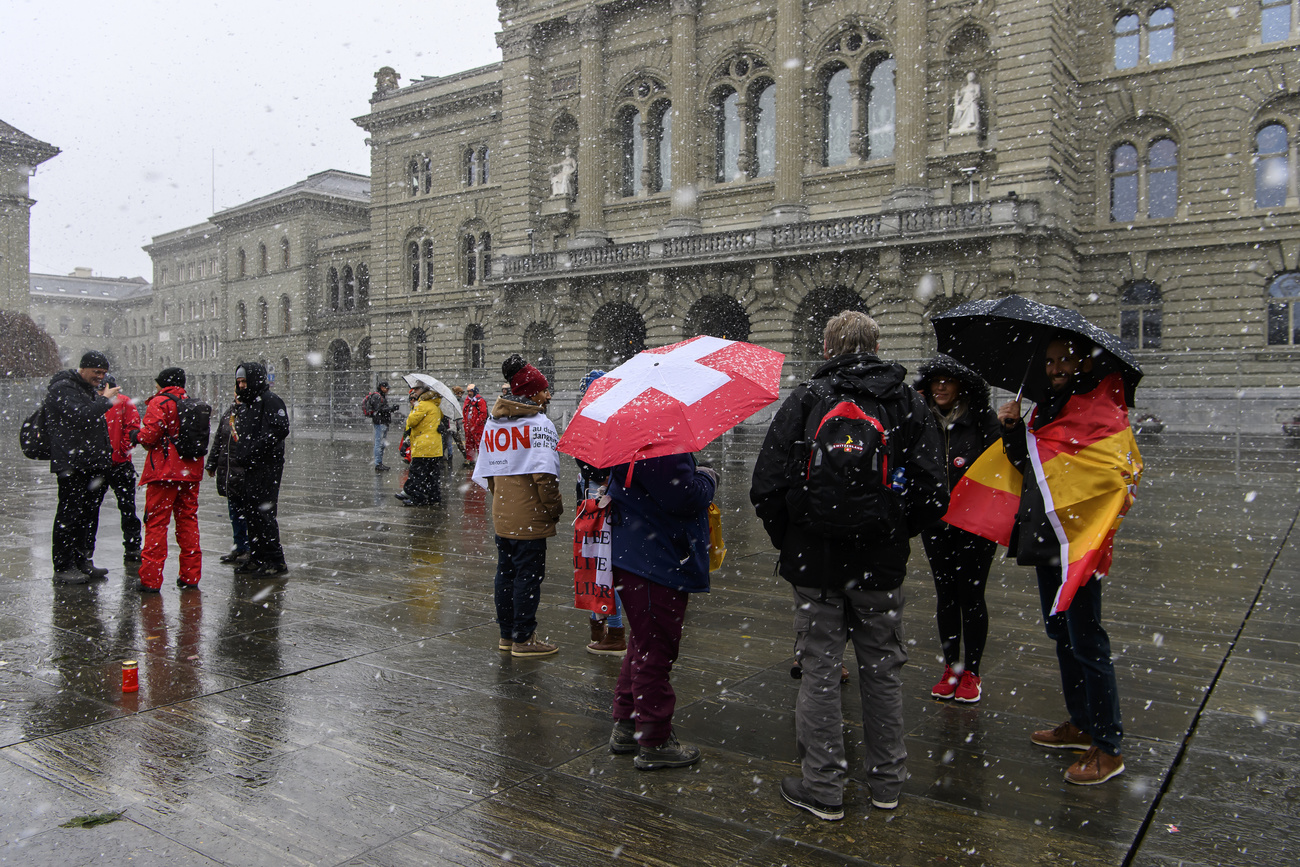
[35,311,1123,820]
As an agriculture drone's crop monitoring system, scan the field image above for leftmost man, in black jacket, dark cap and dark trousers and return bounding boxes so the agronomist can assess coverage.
[44,351,118,584]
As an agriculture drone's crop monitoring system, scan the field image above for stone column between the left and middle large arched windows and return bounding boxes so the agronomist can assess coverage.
[663,0,701,235]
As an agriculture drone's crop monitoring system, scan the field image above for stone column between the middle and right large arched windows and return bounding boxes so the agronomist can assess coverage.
[764,0,806,224]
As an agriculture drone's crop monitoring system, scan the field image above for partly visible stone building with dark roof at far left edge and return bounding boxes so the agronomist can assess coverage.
[0,121,59,313]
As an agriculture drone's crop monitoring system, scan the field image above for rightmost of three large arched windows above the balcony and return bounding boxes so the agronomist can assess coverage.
[820,27,897,166]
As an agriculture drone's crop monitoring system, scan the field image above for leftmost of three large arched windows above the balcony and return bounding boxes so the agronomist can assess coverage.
[615,75,672,196]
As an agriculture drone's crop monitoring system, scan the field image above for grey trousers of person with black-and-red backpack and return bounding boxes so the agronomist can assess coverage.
[794,588,907,803]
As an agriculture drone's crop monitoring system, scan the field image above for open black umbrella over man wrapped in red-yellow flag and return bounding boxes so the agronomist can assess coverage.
[932,295,1141,407]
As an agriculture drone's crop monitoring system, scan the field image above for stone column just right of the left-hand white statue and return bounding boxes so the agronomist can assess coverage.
[571,5,610,247]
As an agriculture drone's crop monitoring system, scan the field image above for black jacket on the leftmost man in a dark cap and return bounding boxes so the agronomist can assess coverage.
[46,370,113,473]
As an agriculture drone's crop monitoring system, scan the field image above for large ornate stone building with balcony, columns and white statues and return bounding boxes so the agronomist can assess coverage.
[358,0,1300,428]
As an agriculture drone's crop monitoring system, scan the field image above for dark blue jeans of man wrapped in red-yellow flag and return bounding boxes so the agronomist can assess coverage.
[1037,565,1125,755]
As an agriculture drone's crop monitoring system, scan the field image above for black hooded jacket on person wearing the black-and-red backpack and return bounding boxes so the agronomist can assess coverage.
[749,352,948,590]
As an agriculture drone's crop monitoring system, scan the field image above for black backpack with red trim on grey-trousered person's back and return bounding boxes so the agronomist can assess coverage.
[787,386,907,543]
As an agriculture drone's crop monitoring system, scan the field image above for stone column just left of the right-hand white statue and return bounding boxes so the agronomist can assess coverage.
[885,0,930,208]
